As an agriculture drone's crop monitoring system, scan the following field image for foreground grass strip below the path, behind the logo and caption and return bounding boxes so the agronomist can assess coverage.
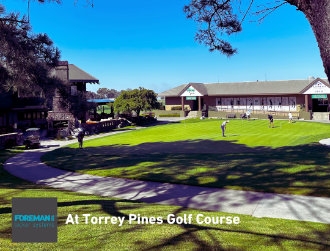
[0,165,330,251]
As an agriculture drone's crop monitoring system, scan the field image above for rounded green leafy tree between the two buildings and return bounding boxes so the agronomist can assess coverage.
[114,87,159,116]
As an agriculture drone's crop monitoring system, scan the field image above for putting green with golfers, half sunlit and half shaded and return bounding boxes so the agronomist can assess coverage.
[43,120,330,197]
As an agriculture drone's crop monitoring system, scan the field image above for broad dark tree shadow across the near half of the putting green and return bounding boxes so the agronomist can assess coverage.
[45,140,330,197]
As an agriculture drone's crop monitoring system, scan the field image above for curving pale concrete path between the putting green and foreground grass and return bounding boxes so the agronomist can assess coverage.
[4,135,330,223]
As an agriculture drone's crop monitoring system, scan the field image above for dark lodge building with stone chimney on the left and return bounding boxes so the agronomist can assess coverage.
[0,61,99,134]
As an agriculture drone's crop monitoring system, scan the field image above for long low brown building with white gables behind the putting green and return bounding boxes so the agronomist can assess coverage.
[158,78,330,120]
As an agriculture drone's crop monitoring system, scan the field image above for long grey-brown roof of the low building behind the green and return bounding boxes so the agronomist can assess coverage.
[158,79,328,97]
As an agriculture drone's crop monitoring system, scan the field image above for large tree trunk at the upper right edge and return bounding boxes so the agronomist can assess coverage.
[287,0,330,81]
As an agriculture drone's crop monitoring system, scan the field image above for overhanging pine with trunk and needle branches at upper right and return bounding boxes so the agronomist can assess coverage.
[184,0,330,81]
